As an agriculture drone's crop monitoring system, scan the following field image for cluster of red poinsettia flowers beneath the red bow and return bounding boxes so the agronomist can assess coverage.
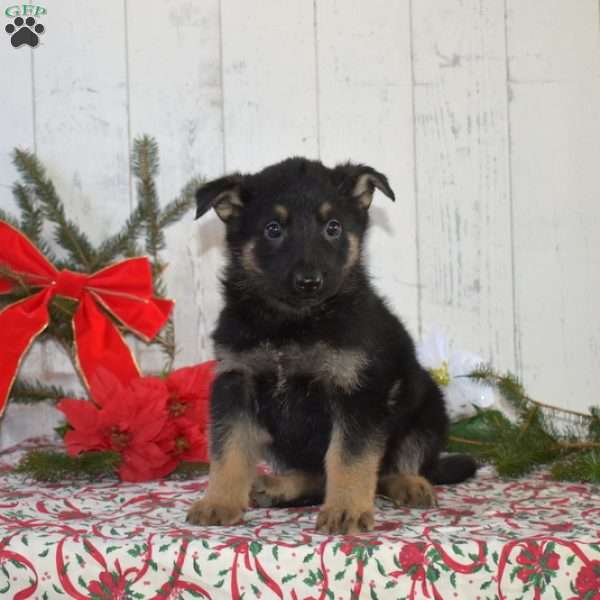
[58,363,214,481]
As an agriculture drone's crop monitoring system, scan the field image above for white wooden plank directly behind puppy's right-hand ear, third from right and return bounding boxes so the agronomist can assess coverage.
[316,0,419,333]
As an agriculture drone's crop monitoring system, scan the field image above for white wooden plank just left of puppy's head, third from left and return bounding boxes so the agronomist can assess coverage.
[127,0,225,367]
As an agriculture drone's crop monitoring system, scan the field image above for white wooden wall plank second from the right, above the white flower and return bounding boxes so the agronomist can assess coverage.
[412,0,515,369]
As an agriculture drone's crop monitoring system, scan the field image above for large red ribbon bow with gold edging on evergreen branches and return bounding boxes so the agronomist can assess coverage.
[0,221,173,415]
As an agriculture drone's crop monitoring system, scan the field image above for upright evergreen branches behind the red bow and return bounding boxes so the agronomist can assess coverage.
[0,136,202,402]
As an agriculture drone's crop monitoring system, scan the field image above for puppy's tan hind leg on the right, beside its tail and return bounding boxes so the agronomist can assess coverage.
[377,433,437,508]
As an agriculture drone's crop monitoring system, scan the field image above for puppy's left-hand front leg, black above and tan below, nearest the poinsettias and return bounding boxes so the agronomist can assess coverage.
[187,373,268,525]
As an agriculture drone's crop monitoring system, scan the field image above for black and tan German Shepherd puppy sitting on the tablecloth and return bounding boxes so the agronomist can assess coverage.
[188,158,476,534]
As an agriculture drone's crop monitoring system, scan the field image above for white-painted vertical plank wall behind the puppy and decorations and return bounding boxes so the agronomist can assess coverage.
[0,0,600,436]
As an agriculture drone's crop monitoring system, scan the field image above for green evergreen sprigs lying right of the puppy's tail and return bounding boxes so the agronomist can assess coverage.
[448,367,600,483]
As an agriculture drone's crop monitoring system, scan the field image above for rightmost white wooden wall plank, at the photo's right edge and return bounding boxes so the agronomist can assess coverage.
[508,0,600,410]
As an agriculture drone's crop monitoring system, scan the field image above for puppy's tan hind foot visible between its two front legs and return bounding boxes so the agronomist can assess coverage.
[251,471,325,508]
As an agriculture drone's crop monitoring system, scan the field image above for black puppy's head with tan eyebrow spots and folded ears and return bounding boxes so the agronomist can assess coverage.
[196,158,394,311]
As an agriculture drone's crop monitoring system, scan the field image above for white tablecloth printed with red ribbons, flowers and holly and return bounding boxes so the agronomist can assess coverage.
[0,438,600,600]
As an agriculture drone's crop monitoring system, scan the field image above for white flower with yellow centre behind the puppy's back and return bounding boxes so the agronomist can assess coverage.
[417,332,496,421]
